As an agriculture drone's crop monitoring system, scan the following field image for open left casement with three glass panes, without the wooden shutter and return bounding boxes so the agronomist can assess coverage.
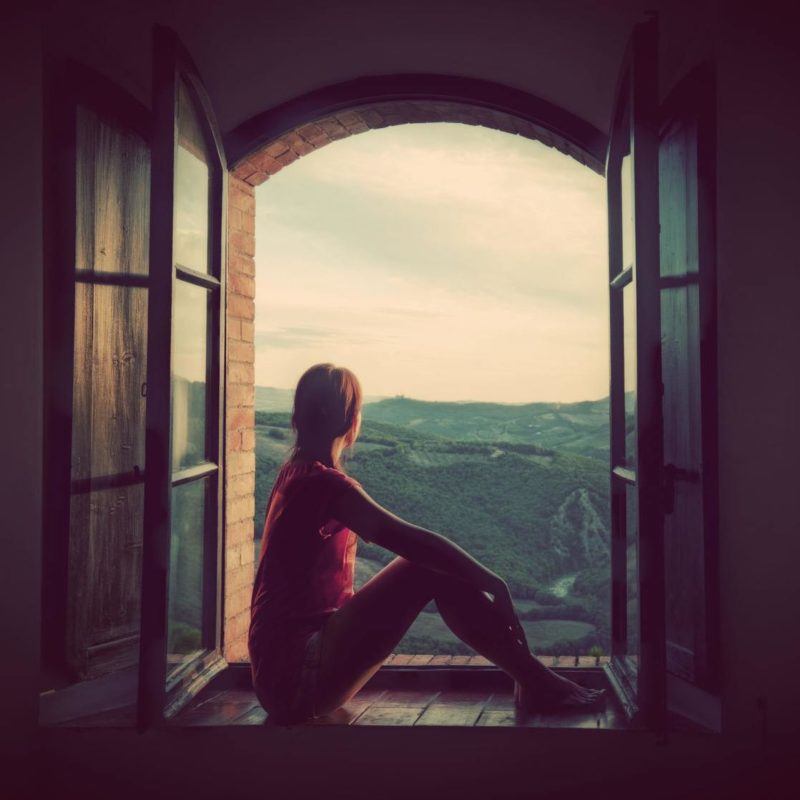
[138,28,227,726]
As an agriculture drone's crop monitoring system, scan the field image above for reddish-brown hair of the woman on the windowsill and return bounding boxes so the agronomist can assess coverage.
[287,363,362,469]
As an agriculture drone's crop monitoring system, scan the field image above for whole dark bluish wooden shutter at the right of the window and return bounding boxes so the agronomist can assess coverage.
[659,67,718,720]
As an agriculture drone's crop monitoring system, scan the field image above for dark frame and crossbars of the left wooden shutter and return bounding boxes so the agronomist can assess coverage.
[40,56,152,688]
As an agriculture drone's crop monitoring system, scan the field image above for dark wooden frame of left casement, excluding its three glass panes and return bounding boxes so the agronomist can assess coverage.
[137,26,228,730]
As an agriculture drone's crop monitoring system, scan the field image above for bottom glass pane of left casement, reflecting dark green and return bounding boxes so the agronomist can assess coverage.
[167,478,209,673]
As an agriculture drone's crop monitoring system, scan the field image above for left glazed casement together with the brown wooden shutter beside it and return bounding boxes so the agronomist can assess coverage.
[42,29,227,725]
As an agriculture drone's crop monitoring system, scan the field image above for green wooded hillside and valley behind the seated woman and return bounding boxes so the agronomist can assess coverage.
[256,412,609,653]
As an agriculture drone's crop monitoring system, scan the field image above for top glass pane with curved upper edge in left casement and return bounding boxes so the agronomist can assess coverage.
[173,81,210,272]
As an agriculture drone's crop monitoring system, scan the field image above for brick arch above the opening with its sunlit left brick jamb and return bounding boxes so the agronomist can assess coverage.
[224,87,606,662]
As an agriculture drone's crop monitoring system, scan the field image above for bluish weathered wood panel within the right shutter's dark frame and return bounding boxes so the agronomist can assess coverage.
[659,114,707,680]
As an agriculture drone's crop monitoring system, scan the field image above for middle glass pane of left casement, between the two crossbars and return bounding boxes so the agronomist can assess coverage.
[172,280,208,470]
